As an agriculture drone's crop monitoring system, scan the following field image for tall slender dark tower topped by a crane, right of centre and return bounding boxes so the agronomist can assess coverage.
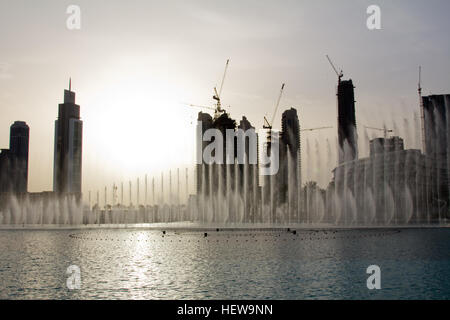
[337,78,358,164]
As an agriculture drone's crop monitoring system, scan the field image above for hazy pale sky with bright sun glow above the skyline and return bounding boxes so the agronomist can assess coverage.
[0,0,450,202]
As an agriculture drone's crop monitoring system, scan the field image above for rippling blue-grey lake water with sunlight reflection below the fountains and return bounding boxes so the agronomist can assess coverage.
[0,228,450,299]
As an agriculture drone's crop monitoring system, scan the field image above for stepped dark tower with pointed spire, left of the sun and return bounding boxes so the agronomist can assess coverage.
[53,82,83,196]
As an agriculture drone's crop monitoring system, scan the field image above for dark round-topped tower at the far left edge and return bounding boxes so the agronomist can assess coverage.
[0,121,30,194]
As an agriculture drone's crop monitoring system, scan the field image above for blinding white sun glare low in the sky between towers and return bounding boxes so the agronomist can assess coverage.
[85,65,195,185]
